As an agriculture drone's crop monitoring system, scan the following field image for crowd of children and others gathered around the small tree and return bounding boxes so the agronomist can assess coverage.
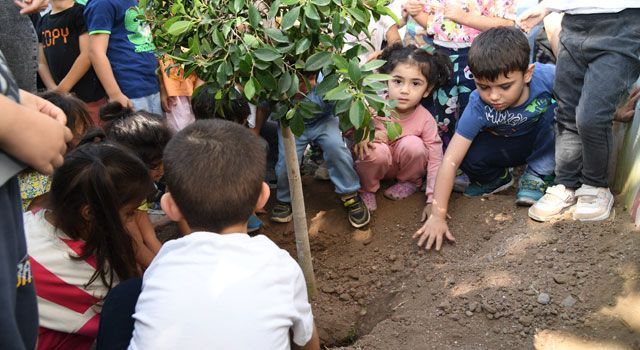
[0,0,640,349]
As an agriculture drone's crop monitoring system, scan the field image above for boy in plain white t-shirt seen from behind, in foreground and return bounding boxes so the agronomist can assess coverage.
[129,120,319,349]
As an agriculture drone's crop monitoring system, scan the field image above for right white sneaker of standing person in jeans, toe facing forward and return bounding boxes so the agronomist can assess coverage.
[573,185,613,221]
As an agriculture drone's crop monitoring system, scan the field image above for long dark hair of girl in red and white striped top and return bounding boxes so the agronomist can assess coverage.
[48,143,154,288]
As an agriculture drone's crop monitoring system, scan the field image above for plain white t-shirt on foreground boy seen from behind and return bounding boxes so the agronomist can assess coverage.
[129,232,313,350]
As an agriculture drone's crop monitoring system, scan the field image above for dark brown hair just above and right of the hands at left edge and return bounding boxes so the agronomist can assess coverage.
[39,91,96,146]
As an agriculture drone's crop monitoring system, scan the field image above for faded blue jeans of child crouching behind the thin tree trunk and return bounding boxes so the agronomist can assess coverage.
[276,116,360,203]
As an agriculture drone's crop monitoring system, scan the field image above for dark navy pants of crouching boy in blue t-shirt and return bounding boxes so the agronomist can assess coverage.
[460,108,555,183]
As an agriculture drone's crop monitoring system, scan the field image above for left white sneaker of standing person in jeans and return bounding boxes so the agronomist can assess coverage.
[529,185,576,222]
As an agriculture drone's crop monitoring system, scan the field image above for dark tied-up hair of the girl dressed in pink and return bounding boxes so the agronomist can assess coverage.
[380,43,453,91]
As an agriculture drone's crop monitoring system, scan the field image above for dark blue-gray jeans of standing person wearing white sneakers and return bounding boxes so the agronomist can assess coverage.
[554,9,640,188]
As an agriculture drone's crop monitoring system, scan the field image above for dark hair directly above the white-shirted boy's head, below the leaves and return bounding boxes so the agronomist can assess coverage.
[191,85,251,125]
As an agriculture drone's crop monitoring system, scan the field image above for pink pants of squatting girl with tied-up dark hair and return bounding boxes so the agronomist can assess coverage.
[356,135,428,192]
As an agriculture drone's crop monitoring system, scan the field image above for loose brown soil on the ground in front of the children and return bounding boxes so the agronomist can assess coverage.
[261,177,640,349]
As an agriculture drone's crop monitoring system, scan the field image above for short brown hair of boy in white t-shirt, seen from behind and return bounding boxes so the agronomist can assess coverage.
[163,119,266,232]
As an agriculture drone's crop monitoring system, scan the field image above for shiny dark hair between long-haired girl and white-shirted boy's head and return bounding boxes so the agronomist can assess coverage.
[100,102,171,169]
